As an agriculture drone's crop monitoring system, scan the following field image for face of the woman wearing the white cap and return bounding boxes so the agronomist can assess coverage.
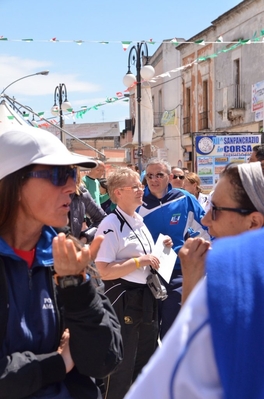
[18,165,76,227]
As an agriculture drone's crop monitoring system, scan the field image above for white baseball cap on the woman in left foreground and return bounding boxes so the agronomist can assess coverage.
[0,126,97,179]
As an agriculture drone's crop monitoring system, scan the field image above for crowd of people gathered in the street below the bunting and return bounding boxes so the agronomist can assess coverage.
[0,127,264,399]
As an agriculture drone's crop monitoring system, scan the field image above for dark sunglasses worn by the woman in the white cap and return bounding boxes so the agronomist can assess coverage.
[23,166,77,186]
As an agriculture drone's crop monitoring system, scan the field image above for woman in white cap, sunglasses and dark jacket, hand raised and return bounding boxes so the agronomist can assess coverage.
[0,128,122,399]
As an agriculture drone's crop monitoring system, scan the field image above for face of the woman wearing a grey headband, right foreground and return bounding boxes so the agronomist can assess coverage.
[201,177,254,237]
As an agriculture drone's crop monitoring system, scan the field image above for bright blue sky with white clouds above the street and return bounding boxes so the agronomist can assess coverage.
[0,0,240,129]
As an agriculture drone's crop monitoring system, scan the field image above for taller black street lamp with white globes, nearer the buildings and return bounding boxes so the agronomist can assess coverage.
[123,41,155,173]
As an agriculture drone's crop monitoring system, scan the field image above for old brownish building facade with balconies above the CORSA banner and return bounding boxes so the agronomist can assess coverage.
[177,0,264,170]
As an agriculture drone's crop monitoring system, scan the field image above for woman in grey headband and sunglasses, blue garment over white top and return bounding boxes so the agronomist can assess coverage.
[126,158,264,399]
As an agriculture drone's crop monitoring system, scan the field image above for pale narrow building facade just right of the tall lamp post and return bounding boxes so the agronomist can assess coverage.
[150,40,183,166]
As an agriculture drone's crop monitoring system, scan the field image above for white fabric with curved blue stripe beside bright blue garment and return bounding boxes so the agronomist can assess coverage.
[125,279,224,399]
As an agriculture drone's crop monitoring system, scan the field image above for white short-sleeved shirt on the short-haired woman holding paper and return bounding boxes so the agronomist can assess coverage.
[95,207,154,284]
